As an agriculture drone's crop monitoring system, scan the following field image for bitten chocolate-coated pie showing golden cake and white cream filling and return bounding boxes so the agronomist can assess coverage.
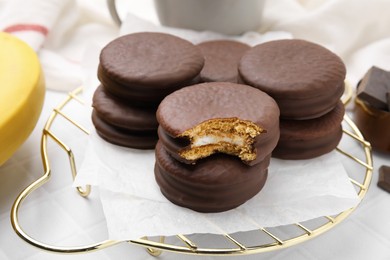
[157,82,280,165]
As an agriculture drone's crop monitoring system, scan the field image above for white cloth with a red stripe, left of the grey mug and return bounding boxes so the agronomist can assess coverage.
[0,0,118,91]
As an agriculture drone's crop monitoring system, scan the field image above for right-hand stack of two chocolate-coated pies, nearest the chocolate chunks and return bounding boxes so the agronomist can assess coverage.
[239,39,346,159]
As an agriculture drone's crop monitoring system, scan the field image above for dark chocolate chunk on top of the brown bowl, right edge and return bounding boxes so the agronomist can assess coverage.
[357,66,390,111]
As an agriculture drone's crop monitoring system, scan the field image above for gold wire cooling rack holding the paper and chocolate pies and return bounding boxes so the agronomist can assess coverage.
[11,87,373,256]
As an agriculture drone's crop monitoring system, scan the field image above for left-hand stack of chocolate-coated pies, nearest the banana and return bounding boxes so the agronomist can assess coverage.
[92,32,204,149]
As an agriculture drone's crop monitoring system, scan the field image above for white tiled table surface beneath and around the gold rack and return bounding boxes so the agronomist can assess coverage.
[0,1,390,260]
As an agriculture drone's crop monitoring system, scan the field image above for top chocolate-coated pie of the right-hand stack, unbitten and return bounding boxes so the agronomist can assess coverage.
[239,40,346,120]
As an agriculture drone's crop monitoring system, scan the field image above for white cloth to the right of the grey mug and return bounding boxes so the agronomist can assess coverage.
[260,0,390,86]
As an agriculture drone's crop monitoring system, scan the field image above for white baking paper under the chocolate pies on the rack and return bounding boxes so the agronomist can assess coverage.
[74,16,359,240]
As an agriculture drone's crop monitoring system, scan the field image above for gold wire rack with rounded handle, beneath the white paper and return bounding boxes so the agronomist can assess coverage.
[11,87,373,256]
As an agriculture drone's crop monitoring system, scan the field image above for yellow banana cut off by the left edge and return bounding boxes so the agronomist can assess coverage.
[0,32,45,165]
